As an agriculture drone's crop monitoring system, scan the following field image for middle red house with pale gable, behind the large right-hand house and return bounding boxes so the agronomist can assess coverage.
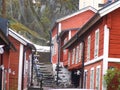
[52,7,96,85]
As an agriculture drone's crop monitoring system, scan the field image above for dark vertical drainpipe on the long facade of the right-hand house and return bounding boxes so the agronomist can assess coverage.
[81,41,85,88]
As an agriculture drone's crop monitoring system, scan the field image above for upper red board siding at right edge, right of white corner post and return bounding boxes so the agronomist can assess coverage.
[108,8,120,58]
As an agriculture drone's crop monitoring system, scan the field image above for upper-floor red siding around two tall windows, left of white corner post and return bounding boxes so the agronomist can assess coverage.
[85,20,104,62]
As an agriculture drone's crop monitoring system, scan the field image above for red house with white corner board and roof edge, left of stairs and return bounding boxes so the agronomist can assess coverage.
[9,29,35,90]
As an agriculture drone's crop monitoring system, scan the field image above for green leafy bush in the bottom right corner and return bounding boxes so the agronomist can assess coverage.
[104,68,120,90]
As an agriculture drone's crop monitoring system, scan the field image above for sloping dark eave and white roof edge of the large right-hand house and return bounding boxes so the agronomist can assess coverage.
[63,0,120,48]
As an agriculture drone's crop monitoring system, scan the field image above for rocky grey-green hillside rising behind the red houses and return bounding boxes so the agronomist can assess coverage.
[0,0,79,45]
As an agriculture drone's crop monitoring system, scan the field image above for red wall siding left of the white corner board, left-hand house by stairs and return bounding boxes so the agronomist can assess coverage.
[9,36,20,90]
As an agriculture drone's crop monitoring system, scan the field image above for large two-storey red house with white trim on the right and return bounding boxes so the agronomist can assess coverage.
[63,0,120,90]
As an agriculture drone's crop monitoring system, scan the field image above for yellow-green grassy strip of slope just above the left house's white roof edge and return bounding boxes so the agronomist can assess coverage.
[9,18,46,45]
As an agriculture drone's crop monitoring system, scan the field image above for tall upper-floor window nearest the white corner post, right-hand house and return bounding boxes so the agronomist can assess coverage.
[94,29,99,58]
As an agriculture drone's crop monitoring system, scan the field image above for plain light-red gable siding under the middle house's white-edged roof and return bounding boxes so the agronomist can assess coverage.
[61,10,94,30]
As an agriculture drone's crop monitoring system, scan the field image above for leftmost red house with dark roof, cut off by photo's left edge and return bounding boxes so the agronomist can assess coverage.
[0,18,16,90]
